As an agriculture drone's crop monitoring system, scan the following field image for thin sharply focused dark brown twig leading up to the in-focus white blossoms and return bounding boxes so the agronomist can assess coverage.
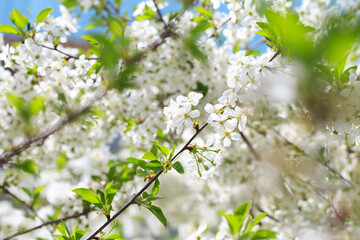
[86,123,208,240]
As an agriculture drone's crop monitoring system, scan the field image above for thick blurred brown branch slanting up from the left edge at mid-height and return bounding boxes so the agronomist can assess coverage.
[0,89,107,167]
